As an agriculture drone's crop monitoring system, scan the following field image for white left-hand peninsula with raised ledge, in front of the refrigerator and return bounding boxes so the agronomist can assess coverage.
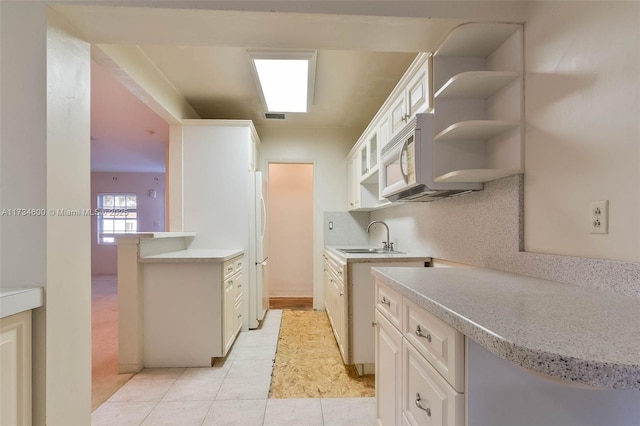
[116,232,244,373]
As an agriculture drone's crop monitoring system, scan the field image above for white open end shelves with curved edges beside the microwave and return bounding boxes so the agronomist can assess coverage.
[433,23,524,182]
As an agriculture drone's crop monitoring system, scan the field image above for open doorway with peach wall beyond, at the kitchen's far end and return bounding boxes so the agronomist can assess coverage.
[268,163,314,310]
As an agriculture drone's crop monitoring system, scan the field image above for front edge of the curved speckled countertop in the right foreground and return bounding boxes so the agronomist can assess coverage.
[372,269,640,390]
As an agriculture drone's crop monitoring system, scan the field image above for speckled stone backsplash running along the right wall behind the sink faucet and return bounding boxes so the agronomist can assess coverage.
[324,175,640,297]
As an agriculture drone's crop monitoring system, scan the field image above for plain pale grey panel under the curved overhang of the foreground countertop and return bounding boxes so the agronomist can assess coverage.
[465,338,640,426]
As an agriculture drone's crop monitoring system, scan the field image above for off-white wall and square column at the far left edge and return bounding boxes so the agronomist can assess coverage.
[0,2,91,425]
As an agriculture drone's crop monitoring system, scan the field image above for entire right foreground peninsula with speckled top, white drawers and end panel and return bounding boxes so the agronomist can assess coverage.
[373,268,640,425]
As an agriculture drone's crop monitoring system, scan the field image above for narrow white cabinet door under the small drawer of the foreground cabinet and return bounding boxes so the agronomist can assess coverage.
[375,309,402,425]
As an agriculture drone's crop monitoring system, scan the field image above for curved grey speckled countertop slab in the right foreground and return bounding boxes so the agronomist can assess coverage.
[372,267,640,389]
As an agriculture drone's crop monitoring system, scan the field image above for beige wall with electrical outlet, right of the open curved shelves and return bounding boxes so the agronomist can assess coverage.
[524,2,640,262]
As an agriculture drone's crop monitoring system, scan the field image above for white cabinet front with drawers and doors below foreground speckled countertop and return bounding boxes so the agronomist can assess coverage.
[375,280,465,426]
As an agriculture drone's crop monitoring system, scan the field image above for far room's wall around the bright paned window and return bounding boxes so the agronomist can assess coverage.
[91,172,165,275]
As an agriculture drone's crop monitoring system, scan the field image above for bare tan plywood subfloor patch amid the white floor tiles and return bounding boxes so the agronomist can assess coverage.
[269,310,375,398]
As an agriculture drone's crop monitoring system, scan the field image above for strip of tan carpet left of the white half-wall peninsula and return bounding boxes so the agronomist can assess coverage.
[91,275,132,411]
